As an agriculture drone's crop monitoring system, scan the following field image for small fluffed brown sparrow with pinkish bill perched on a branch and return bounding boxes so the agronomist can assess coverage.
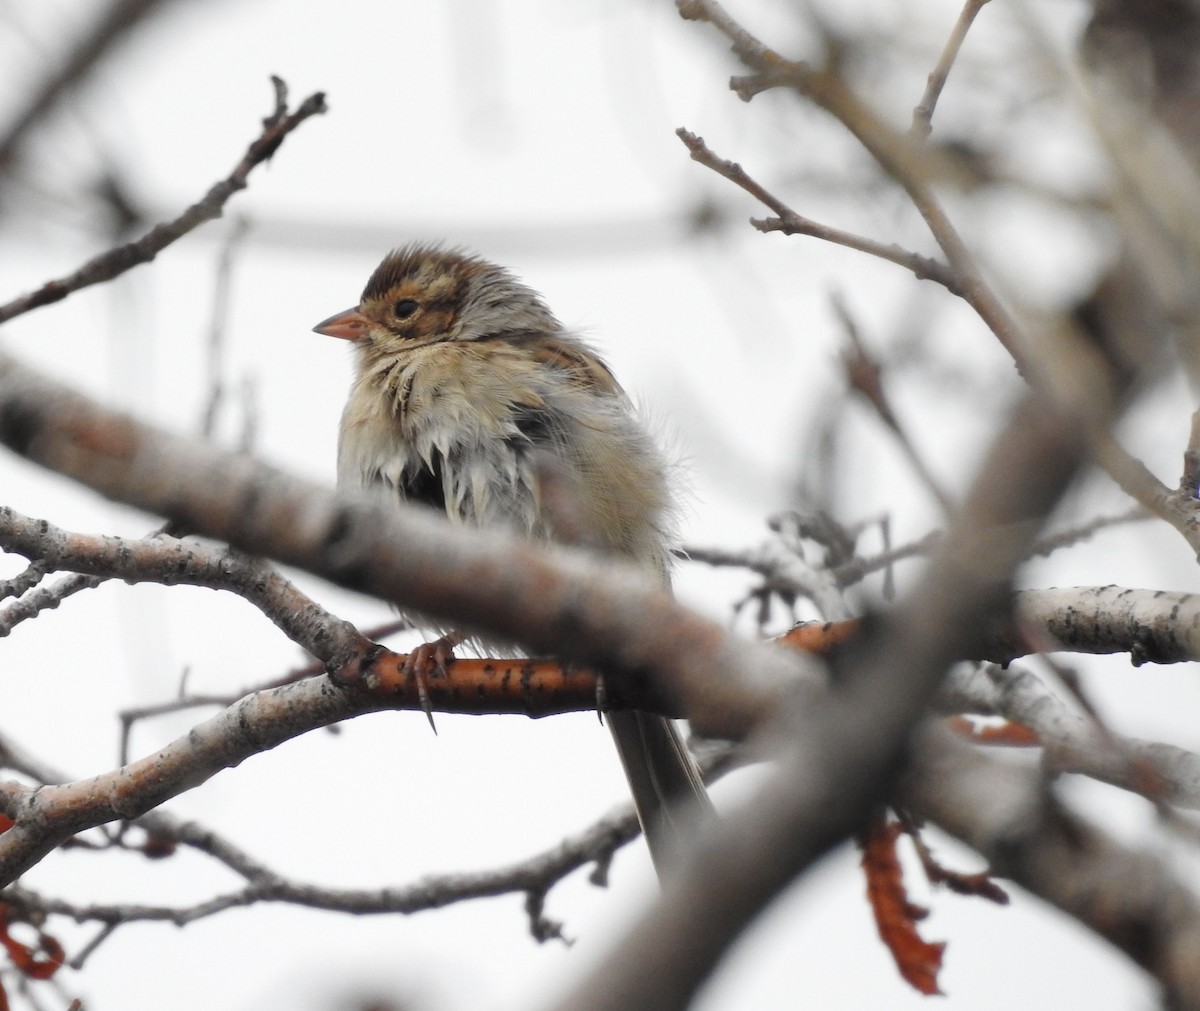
[313,245,710,874]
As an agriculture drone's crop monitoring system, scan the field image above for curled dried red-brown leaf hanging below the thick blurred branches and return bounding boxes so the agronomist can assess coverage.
[859,815,946,995]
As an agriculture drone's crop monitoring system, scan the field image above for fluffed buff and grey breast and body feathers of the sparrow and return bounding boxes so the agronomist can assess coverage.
[338,342,668,572]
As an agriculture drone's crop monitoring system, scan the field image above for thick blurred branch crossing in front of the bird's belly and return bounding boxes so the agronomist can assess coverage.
[0,355,803,735]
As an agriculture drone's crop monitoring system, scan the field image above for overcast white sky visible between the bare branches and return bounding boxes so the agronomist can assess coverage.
[0,0,1200,1011]
